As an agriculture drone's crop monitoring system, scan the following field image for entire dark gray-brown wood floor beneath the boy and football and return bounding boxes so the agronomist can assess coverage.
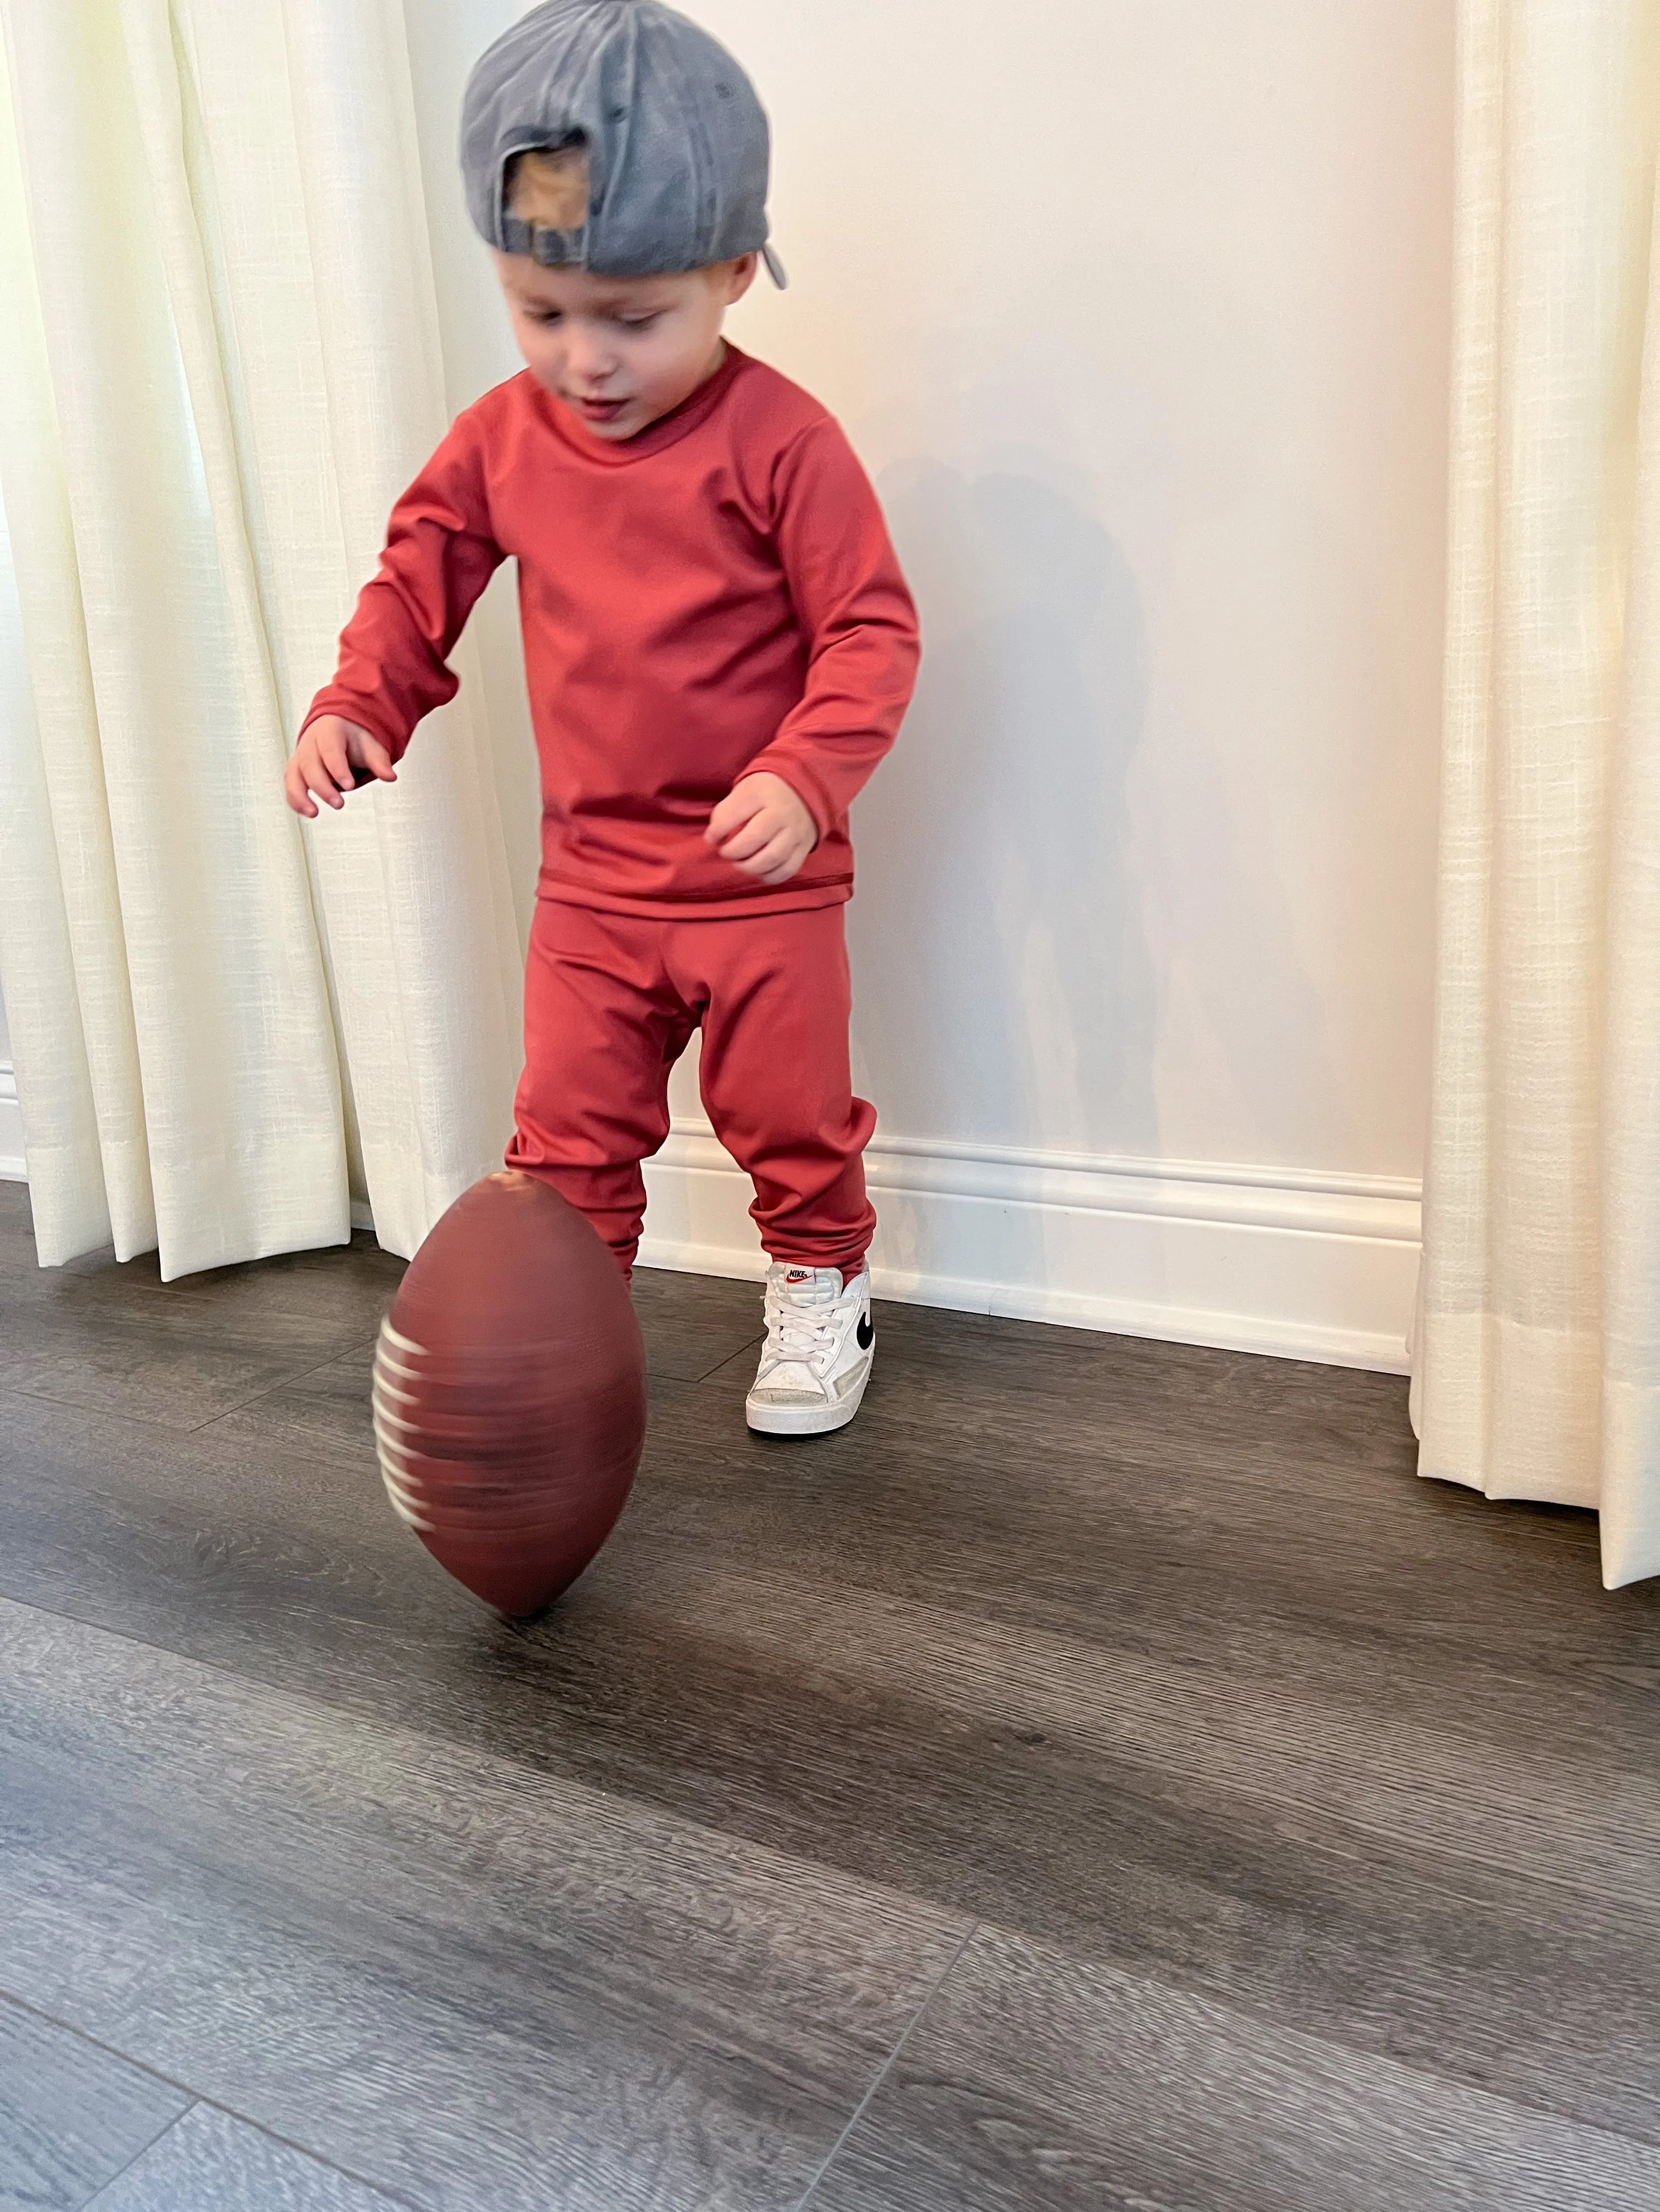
[0,1188,1660,2212]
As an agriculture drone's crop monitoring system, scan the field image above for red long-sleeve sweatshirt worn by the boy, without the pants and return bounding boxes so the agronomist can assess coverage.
[305,347,918,918]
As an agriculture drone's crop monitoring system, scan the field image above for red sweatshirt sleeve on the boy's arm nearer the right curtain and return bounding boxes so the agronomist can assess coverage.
[746,418,921,836]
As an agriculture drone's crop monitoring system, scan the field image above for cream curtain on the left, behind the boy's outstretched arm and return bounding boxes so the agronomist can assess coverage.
[0,0,520,1276]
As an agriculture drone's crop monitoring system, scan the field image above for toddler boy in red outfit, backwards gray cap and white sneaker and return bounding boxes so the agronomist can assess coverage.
[285,0,916,1435]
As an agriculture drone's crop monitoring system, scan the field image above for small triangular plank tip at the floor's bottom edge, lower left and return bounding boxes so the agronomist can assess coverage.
[86,2104,407,2212]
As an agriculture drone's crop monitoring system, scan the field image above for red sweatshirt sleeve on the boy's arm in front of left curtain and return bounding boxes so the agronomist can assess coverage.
[301,416,504,761]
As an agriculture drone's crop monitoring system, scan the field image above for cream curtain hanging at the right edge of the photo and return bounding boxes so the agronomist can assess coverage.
[1414,0,1660,1588]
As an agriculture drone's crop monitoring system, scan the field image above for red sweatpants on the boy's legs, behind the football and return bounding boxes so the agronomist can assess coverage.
[507,898,877,1274]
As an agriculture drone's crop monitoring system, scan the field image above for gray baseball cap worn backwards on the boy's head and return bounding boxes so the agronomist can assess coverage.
[461,0,783,285]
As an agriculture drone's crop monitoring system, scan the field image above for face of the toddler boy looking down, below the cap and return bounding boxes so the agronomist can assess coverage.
[491,252,757,445]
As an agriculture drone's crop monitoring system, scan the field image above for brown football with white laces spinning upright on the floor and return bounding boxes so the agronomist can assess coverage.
[374,1170,646,1619]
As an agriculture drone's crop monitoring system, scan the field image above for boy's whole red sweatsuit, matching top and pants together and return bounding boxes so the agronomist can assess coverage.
[305,345,916,1267]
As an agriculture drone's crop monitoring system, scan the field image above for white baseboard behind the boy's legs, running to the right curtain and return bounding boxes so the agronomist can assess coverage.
[640,1119,1419,1374]
